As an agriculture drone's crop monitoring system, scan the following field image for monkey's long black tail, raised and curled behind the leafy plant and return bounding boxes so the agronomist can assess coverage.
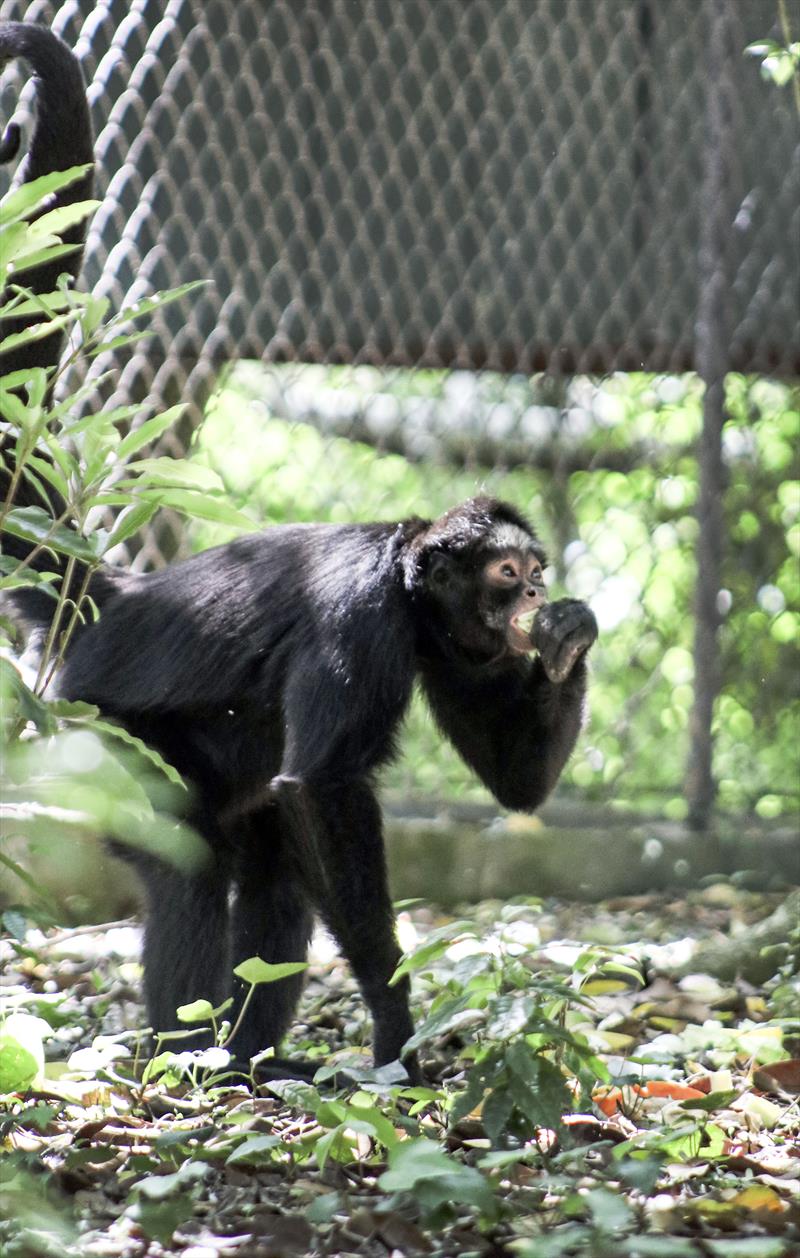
[0,21,100,624]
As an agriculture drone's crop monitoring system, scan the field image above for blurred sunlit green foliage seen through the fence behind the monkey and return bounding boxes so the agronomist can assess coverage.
[192,364,800,816]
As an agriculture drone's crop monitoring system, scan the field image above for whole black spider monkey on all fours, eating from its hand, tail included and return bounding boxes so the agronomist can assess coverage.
[0,17,596,1077]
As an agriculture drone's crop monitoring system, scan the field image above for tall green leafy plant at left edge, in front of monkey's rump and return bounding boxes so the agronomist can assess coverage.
[0,169,244,920]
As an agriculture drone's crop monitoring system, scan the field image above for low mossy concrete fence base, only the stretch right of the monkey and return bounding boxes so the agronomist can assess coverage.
[386,805,800,906]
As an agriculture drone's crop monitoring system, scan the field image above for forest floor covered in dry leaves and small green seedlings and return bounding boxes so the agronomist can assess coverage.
[0,882,800,1258]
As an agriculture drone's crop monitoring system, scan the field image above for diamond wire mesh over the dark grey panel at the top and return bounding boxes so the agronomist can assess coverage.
[0,0,800,420]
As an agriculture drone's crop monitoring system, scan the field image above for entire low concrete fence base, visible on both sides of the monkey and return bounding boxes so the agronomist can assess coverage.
[0,799,800,923]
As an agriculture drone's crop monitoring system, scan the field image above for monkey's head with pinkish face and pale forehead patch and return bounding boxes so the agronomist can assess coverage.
[406,498,547,662]
